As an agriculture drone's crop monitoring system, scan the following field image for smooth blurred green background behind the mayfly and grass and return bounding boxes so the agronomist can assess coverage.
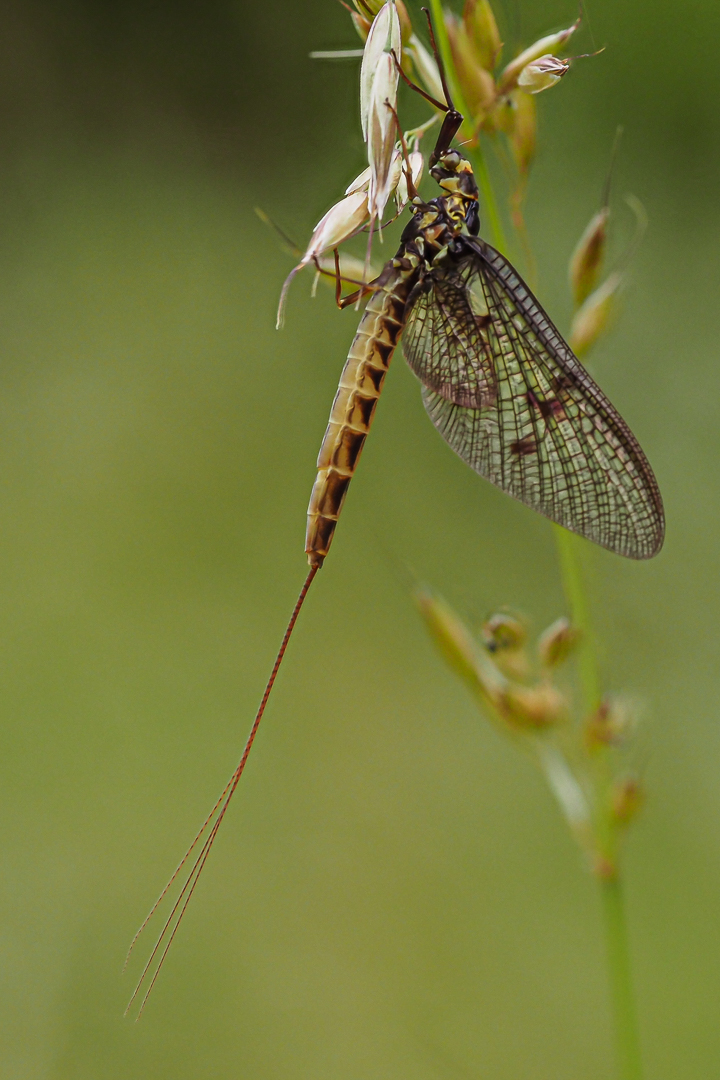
[0,0,720,1080]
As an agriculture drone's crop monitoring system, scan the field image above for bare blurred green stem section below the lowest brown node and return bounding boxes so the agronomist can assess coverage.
[599,877,642,1080]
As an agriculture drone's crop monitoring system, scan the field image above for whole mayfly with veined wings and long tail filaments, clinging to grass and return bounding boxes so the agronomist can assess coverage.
[128,16,664,1013]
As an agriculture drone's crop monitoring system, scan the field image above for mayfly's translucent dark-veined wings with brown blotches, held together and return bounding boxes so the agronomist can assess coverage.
[405,238,665,558]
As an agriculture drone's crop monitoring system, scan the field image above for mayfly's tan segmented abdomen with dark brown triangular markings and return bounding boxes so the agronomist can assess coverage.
[305,279,410,566]
